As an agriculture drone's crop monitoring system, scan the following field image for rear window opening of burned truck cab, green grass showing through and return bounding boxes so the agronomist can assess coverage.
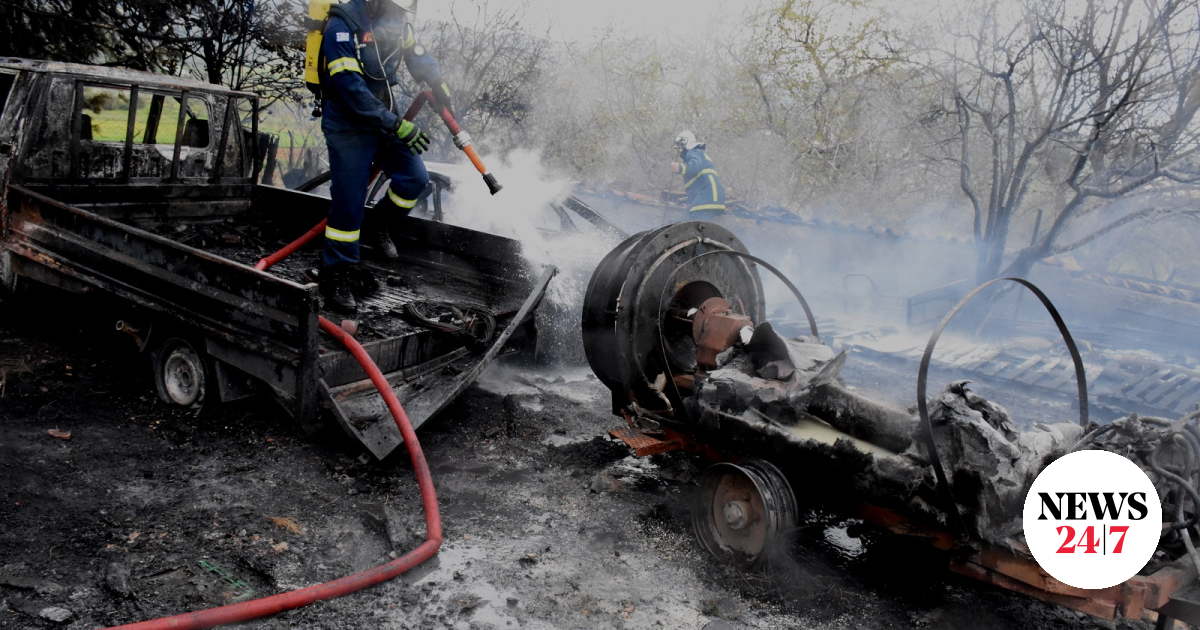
[73,83,215,180]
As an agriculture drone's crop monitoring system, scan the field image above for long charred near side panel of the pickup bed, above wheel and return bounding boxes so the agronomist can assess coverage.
[2,185,319,418]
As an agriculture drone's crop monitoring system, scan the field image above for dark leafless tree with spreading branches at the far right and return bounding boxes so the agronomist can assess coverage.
[932,0,1200,281]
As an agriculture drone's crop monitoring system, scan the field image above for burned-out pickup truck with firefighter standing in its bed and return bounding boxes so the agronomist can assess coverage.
[0,59,554,458]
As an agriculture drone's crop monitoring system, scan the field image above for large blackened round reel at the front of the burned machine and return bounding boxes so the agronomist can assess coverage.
[583,222,766,416]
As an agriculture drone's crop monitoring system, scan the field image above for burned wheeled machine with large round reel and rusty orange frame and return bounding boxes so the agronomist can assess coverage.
[582,223,1200,628]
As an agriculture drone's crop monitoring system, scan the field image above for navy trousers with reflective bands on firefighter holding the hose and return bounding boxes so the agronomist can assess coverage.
[323,133,430,266]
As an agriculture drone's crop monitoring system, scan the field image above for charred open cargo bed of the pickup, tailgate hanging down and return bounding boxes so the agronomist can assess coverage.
[6,178,553,458]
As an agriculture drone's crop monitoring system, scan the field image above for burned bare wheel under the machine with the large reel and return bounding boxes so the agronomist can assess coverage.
[691,460,798,569]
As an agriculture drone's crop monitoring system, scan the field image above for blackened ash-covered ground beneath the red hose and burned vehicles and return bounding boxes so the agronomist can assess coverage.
[0,295,1148,630]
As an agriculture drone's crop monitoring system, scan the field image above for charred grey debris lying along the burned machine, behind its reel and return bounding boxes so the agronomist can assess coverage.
[688,326,1082,545]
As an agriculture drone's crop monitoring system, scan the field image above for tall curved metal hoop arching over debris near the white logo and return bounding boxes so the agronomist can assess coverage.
[917,277,1087,530]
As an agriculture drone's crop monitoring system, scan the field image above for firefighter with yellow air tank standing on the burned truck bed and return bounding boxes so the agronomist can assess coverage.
[319,0,450,312]
